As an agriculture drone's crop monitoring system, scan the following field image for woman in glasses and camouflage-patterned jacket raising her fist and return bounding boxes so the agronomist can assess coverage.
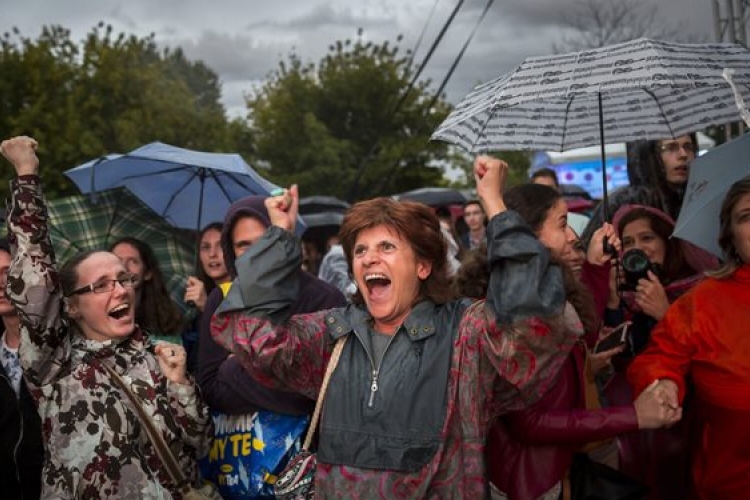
[0,137,208,499]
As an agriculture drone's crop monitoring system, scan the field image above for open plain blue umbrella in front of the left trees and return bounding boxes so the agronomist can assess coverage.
[65,142,277,229]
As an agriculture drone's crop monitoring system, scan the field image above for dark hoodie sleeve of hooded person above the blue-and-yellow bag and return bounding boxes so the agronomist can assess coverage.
[198,288,312,415]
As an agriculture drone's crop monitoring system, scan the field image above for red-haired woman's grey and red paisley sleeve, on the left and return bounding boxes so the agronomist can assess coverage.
[211,226,334,399]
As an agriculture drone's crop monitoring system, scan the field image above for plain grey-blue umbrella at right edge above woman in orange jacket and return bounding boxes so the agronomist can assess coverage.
[673,134,750,257]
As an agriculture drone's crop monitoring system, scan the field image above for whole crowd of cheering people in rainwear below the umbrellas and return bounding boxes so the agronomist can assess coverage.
[0,131,750,500]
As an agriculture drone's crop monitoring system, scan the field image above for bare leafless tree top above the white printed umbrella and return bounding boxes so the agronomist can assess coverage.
[552,0,700,53]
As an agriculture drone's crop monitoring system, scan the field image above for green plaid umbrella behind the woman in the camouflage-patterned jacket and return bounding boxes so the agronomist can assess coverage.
[48,188,195,310]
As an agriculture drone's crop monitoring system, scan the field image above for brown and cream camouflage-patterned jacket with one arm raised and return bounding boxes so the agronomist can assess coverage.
[7,176,208,499]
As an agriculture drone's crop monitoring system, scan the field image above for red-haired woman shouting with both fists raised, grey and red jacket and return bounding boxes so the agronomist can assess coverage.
[212,157,580,499]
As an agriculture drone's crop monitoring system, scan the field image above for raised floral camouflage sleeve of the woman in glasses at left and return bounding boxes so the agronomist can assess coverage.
[6,175,70,386]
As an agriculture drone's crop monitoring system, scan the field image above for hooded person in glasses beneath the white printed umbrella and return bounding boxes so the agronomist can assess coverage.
[581,134,698,244]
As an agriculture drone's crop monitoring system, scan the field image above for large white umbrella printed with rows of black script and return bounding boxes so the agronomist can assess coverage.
[432,38,750,153]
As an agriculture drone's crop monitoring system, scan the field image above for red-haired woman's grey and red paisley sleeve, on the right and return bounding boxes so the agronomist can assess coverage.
[478,211,582,415]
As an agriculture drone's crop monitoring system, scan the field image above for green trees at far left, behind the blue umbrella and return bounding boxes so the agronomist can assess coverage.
[0,23,251,197]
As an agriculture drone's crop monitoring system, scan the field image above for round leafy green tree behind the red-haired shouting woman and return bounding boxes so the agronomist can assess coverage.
[248,31,456,201]
